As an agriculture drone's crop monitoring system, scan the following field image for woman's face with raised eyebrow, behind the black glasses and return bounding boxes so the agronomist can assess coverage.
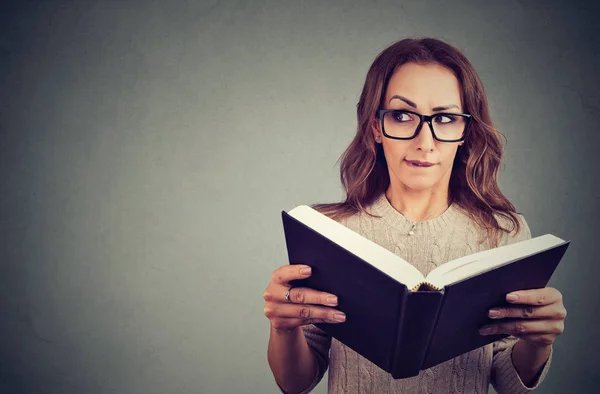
[373,63,463,191]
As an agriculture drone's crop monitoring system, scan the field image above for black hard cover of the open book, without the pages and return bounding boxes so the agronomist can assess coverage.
[282,211,569,379]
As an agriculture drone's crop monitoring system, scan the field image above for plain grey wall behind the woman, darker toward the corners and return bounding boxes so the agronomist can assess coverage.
[0,1,600,394]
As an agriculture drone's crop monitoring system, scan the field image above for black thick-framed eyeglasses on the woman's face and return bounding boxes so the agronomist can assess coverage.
[377,109,471,142]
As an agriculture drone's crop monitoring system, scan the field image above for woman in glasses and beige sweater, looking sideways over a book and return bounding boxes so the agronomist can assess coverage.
[264,38,566,394]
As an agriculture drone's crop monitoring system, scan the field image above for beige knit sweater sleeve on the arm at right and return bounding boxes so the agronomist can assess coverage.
[490,215,553,394]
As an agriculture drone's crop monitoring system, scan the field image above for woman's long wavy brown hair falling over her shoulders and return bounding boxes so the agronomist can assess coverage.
[312,38,520,246]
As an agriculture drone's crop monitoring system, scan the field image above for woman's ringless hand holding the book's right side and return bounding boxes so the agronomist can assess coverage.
[479,287,567,347]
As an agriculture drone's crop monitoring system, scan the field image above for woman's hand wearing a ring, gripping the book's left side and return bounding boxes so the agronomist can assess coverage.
[263,264,346,332]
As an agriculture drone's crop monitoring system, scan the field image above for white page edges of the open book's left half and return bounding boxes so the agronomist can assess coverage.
[288,205,425,289]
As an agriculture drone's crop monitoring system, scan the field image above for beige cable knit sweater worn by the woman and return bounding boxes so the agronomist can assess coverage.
[282,193,552,394]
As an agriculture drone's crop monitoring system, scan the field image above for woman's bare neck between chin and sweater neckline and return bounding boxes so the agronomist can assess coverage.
[385,185,449,222]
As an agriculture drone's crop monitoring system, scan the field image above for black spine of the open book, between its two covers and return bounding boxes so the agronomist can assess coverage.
[391,289,444,379]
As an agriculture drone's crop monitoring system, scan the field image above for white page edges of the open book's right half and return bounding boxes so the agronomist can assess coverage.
[426,234,565,287]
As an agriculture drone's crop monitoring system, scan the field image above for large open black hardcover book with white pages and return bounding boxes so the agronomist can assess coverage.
[282,205,570,379]
